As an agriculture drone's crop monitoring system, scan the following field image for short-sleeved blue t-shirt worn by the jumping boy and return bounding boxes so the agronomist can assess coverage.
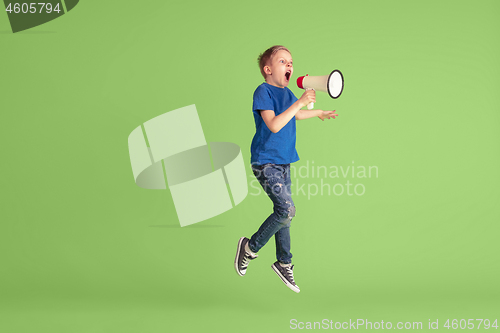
[251,82,299,165]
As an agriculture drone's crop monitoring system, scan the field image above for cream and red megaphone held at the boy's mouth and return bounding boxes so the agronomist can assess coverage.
[297,69,344,110]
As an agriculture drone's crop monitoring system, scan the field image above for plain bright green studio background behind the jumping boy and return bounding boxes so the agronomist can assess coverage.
[0,0,500,333]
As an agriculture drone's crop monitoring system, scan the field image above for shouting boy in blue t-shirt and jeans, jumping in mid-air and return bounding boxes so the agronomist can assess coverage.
[234,45,337,293]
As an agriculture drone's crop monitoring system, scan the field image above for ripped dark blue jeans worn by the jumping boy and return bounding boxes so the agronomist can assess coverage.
[248,164,295,264]
